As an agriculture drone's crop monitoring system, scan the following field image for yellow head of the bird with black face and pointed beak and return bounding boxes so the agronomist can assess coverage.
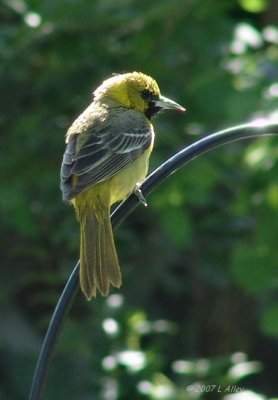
[94,72,185,119]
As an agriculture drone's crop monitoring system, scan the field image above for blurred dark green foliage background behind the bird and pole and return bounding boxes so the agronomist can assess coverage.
[0,0,278,400]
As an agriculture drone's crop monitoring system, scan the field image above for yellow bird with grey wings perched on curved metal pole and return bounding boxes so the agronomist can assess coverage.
[60,72,185,300]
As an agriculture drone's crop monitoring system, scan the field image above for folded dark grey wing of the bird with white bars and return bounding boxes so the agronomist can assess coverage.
[61,110,153,200]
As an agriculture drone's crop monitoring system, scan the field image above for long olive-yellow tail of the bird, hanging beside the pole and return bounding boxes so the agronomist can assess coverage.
[76,204,122,300]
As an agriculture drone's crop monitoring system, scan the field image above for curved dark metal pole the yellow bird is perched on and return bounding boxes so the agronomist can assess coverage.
[29,122,278,400]
